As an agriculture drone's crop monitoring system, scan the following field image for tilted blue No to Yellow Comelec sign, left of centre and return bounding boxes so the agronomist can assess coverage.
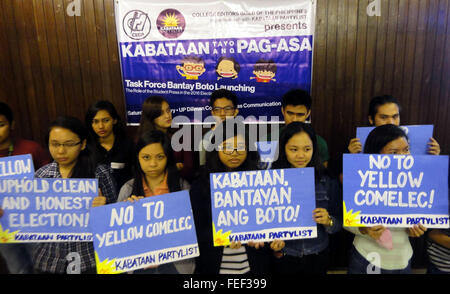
[90,191,199,274]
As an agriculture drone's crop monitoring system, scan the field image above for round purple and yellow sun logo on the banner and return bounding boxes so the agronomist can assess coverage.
[156,9,186,39]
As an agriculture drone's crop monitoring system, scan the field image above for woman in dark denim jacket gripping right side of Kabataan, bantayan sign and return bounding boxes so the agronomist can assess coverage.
[271,122,342,274]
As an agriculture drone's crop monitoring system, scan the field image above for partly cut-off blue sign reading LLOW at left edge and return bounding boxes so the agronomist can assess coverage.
[0,154,34,179]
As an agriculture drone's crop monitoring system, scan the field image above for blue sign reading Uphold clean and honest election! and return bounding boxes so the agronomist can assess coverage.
[0,178,98,243]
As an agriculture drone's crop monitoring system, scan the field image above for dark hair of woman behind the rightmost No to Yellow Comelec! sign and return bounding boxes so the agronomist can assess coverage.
[364,124,409,154]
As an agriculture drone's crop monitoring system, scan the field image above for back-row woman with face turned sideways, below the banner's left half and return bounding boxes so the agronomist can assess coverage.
[138,96,194,181]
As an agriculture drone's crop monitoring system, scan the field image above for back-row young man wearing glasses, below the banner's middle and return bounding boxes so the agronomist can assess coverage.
[198,89,239,166]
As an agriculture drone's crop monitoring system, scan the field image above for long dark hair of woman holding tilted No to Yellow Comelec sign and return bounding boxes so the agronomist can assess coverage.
[132,130,181,196]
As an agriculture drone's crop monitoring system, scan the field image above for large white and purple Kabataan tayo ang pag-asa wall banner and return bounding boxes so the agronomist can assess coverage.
[115,0,316,125]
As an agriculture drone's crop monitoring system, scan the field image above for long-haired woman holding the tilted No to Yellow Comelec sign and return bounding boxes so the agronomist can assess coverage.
[118,130,195,274]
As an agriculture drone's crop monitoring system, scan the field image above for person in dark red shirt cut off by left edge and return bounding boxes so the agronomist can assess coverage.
[0,102,50,274]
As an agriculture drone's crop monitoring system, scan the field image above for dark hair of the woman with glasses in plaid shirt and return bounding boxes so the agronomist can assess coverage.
[46,116,96,178]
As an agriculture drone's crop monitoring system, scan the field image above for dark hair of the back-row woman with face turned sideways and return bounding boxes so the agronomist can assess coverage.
[138,96,169,137]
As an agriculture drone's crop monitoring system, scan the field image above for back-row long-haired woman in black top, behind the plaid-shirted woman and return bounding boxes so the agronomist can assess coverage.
[85,100,134,190]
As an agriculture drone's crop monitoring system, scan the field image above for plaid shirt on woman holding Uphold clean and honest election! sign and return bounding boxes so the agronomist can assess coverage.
[33,162,117,274]
